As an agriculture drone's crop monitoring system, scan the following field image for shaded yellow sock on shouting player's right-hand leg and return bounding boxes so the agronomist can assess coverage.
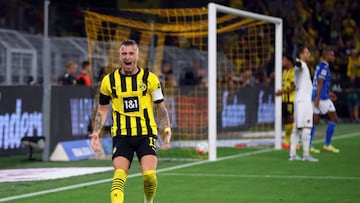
[142,170,157,202]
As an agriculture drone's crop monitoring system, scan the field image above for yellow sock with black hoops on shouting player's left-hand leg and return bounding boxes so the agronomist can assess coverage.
[111,169,126,203]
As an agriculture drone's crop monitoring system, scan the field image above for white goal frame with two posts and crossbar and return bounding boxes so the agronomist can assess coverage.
[208,3,283,161]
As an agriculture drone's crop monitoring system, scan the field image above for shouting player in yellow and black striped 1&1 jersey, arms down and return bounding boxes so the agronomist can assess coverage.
[90,40,171,203]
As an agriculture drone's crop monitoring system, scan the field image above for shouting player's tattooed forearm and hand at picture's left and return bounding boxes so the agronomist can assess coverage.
[90,104,109,152]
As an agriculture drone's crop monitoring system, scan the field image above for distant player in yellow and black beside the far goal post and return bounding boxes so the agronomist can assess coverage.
[275,55,295,149]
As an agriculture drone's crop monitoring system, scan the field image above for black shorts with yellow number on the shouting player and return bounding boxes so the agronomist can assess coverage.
[112,135,156,164]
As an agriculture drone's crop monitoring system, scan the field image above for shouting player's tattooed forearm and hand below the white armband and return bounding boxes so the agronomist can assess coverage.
[156,102,171,149]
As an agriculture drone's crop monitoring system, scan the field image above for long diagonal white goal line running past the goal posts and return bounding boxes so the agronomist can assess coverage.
[0,132,360,202]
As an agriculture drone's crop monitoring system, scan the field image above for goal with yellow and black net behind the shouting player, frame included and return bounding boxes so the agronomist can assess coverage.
[85,3,281,160]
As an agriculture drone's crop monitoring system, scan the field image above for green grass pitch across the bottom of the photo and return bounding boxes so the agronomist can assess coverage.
[0,124,360,203]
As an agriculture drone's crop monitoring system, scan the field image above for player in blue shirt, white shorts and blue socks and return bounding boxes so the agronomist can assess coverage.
[309,48,340,153]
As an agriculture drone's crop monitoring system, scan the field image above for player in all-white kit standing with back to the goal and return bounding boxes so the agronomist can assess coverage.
[289,47,319,162]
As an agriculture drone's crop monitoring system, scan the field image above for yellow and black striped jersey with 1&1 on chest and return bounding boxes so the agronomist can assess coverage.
[100,68,164,136]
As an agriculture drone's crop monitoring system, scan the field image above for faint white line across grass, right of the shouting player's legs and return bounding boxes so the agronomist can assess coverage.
[161,173,360,181]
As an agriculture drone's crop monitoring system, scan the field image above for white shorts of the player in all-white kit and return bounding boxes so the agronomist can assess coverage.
[294,101,313,128]
